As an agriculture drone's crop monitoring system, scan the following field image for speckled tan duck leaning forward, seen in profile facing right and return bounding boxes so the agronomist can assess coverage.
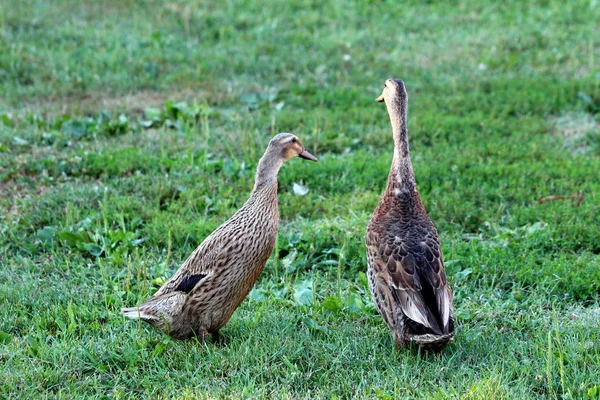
[121,133,317,340]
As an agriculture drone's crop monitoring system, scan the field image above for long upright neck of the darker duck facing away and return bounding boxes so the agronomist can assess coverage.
[388,104,416,193]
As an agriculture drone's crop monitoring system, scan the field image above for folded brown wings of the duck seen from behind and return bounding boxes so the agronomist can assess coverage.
[366,230,452,335]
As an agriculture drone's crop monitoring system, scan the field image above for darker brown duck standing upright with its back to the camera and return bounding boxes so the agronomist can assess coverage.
[365,79,454,352]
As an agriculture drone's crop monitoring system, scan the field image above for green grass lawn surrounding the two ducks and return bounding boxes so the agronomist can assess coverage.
[0,0,600,399]
